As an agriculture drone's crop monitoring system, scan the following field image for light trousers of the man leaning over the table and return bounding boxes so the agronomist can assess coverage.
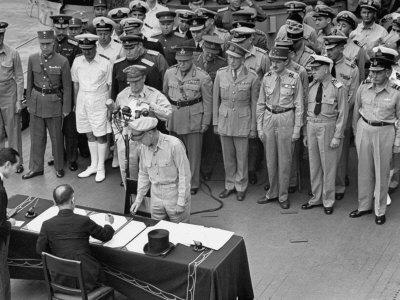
[150,184,190,223]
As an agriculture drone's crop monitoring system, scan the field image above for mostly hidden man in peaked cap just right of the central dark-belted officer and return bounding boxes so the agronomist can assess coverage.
[194,35,228,180]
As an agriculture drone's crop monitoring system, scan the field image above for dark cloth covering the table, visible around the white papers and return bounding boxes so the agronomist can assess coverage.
[8,195,254,300]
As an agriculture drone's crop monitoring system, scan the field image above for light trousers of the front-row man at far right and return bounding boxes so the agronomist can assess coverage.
[356,118,395,216]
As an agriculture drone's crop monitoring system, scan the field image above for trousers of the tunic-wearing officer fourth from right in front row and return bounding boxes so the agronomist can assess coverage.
[221,135,249,192]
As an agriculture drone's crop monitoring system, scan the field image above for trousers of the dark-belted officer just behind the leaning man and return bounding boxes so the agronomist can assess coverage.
[178,132,203,189]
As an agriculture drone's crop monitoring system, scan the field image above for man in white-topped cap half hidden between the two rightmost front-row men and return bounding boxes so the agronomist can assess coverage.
[324,31,359,200]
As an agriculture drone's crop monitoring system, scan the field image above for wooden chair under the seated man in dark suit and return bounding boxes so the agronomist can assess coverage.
[42,252,114,300]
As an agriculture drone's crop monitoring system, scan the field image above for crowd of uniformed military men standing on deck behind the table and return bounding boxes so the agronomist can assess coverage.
[0,0,400,224]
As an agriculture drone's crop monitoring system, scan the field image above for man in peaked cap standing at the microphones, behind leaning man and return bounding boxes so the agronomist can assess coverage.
[113,65,172,183]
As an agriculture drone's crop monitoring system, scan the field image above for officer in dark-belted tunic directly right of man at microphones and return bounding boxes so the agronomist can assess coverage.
[163,44,213,194]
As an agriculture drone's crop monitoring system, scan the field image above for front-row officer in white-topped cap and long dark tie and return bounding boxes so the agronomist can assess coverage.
[301,55,349,215]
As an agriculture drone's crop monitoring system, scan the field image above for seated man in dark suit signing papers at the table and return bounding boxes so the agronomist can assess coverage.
[36,184,114,291]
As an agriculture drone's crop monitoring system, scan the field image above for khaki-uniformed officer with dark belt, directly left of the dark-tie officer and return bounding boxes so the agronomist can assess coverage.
[257,47,304,209]
